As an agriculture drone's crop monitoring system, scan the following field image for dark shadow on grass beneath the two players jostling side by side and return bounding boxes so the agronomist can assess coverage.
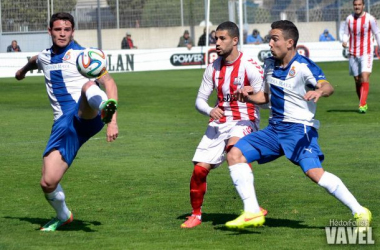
[177,213,325,234]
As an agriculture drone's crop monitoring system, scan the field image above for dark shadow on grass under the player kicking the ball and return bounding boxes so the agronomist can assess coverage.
[4,216,102,233]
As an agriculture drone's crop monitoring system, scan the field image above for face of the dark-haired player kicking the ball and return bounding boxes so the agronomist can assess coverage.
[49,20,74,48]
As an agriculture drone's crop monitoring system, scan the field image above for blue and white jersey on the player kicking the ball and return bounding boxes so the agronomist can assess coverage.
[37,41,89,120]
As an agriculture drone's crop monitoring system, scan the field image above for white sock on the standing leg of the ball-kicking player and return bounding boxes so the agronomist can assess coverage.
[45,184,70,221]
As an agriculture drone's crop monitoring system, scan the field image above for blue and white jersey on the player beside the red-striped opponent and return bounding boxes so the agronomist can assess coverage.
[264,53,326,129]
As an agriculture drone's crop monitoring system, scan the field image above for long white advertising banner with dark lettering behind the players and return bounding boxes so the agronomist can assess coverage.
[0,42,356,77]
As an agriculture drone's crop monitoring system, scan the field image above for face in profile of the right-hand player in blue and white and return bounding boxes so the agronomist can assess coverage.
[269,29,293,60]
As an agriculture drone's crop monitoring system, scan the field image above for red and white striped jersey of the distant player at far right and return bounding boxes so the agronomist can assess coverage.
[344,12,380,57]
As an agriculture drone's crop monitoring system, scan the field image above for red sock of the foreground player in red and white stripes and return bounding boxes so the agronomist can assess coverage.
[190,165,210,215]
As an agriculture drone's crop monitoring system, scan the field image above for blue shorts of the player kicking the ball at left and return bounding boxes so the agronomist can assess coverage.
[43,102,104,166]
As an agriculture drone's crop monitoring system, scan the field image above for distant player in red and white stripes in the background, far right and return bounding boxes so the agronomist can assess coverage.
[342,0,380,113]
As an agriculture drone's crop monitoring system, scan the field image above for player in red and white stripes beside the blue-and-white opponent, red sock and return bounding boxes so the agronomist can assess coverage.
[181,22,266,228]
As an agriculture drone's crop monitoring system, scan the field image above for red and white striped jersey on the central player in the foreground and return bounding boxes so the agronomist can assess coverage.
[198,52,264,123]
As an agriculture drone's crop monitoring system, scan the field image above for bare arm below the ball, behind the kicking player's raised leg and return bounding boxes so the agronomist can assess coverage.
[97,73,119,142]
